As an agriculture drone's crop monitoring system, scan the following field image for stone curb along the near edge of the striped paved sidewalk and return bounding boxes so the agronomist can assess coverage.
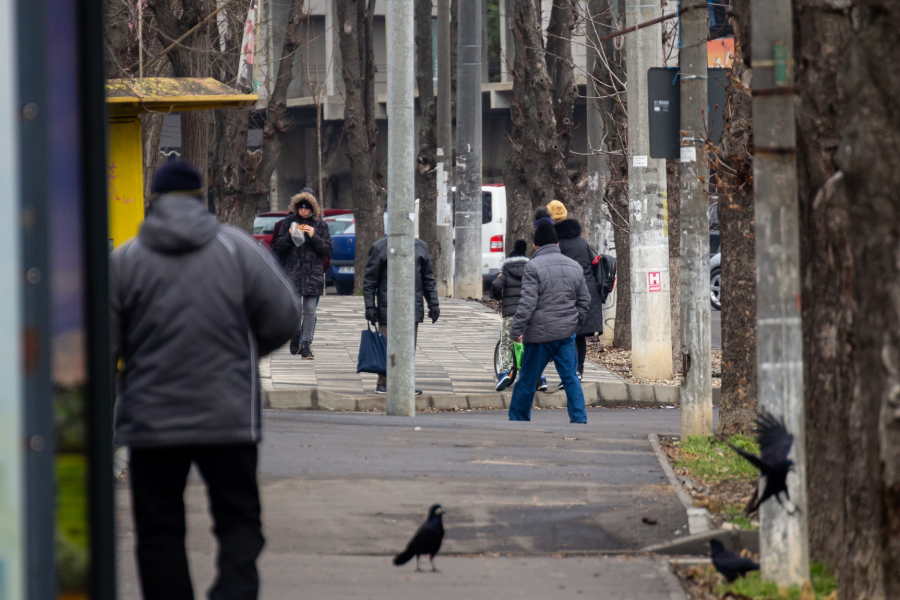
[262,377,712,412]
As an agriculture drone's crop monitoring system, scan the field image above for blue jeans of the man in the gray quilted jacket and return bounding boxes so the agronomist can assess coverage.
[509,334,587,423]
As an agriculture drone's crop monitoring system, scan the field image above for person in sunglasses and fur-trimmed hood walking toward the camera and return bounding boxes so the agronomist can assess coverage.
[272,192,332,360]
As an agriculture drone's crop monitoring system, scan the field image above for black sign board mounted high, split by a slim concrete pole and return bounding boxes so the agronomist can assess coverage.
[647,67,728,159]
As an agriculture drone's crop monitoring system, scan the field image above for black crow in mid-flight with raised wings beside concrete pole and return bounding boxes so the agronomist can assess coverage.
[729,411,796,515]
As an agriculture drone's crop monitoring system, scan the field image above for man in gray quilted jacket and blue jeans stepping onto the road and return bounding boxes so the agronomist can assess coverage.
[509,220,591,423]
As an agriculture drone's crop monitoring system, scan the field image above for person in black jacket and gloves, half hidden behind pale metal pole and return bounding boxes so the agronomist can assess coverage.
[363,238,441,395]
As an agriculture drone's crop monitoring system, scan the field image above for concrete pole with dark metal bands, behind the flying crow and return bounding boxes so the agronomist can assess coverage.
[750,0,809,585]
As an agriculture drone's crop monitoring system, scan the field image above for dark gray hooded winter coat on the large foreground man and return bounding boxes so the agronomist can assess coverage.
[109,196,299,447]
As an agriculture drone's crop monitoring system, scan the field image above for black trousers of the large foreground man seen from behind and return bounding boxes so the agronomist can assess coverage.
[130,444,265,600]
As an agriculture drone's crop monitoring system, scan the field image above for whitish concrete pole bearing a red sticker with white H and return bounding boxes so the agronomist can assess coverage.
[625,0,672,379]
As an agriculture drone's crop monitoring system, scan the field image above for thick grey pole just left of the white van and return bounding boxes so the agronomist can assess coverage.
[453,0,483,298]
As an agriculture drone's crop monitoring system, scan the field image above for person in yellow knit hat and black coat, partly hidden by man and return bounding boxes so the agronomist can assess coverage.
[547,200,603,389]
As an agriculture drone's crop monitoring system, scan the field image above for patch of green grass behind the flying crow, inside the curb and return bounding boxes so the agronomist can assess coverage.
[676,434,759,483]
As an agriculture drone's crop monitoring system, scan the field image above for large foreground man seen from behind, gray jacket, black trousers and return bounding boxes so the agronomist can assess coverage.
[110,161,299,600]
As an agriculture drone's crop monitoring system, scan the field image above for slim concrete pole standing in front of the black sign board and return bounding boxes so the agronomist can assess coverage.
[672,0,713,439]
